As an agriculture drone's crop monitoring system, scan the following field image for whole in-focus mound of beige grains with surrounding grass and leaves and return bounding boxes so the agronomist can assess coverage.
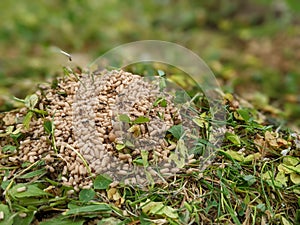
[0,69,300,225]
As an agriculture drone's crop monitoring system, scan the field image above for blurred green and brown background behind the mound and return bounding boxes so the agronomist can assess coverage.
[0,0,300,126]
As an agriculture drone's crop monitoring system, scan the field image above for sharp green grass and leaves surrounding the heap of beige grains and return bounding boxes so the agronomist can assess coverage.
[0,65,300,225]
